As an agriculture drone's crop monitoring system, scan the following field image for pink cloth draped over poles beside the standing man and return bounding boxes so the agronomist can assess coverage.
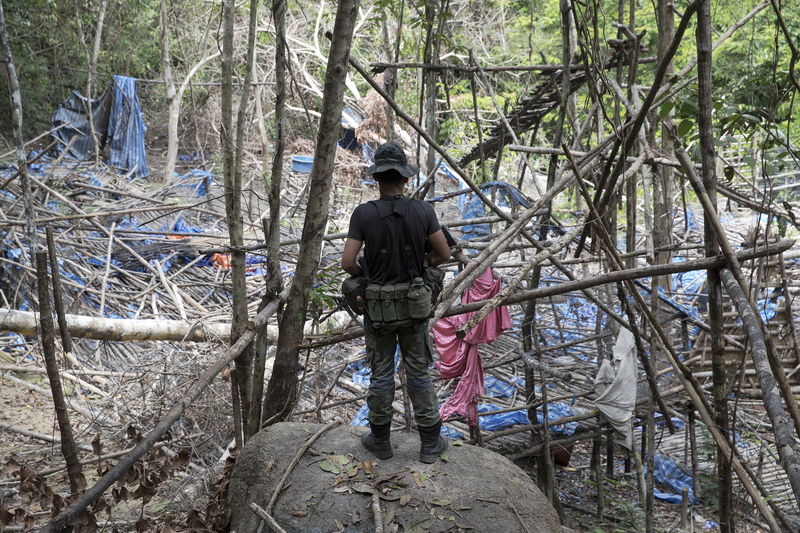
[433,268,511,426]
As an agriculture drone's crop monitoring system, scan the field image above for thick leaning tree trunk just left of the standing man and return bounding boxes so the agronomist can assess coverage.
[264,0,358,421]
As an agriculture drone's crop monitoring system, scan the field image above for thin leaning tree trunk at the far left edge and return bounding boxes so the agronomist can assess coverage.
[0,0,38,252]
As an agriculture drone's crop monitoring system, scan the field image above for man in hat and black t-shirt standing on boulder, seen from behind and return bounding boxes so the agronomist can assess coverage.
[342,141,450,463]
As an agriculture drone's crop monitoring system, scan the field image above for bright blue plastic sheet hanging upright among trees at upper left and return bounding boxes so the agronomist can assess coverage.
[108,76,149,178]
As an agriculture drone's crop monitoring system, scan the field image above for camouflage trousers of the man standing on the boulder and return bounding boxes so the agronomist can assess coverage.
[364,317,439,427]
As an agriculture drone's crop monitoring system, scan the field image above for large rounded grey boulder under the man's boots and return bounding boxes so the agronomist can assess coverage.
[228,422,561,533]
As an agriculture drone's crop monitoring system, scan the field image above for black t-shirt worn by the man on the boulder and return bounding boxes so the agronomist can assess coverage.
[347,195,440,284]
